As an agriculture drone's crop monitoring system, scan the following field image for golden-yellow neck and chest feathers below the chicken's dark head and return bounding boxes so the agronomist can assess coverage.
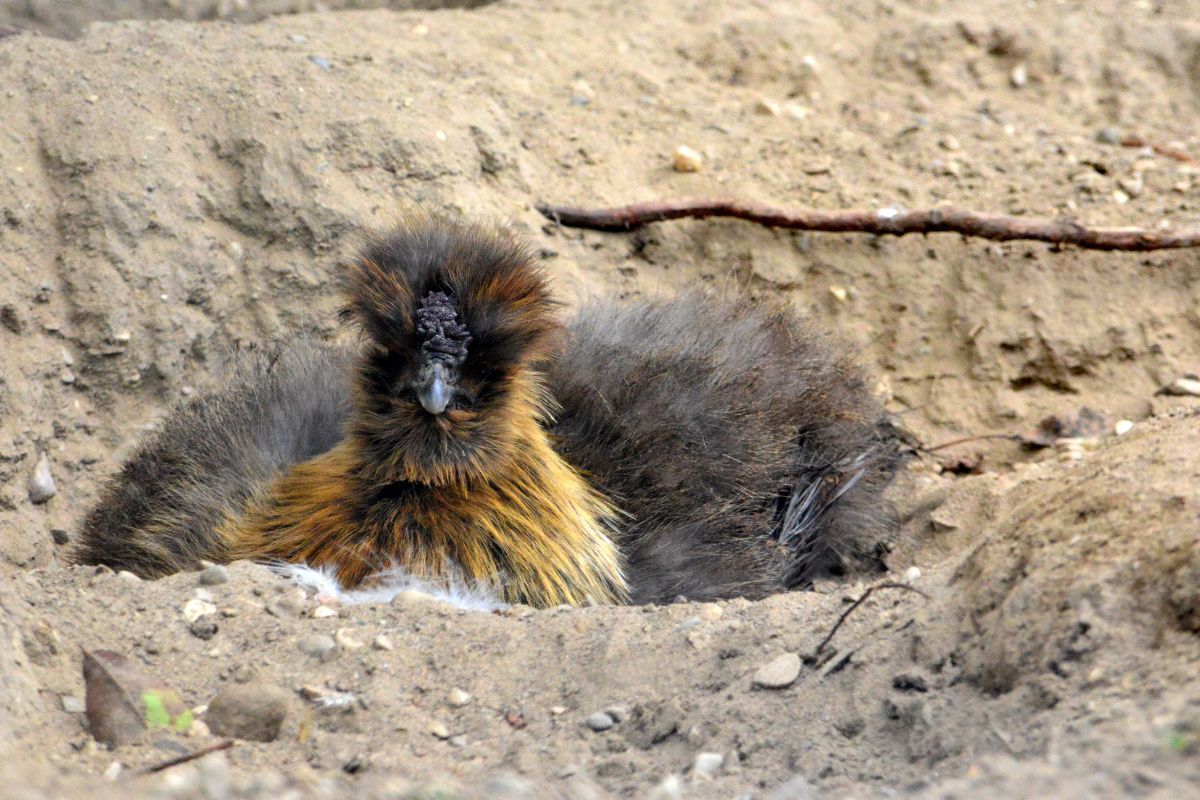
[221,374,628,607]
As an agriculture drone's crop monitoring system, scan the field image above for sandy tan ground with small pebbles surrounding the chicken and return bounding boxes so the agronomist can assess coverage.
[0,0,1200,798]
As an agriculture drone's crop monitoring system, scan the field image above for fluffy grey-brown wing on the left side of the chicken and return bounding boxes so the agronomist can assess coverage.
[76,337,353,578]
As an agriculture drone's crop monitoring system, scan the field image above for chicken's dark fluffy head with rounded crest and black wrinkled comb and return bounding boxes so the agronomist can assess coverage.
[344,217,558,482]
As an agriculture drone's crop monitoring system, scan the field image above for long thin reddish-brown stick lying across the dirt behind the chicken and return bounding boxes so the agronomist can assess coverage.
[538,198,1200,251]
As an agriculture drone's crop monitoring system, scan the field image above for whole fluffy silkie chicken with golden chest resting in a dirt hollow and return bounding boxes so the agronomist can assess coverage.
[83,212,895,606]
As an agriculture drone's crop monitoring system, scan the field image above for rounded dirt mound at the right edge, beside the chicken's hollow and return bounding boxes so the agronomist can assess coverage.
[950,413,1200,693]
